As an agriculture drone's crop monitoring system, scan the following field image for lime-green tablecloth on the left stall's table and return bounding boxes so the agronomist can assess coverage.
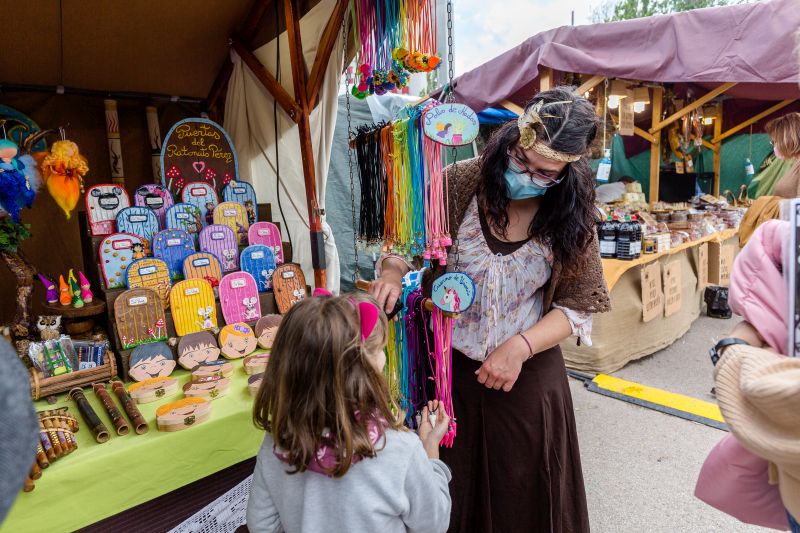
[0,361,264,533]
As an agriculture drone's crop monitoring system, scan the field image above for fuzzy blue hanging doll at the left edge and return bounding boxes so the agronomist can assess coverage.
[0,139,42,223]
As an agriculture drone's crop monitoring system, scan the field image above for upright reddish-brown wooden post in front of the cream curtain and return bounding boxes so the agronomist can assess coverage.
[283,0,327,288]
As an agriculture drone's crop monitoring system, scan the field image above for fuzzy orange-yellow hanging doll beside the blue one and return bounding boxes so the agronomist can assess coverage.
[37,140,89,220]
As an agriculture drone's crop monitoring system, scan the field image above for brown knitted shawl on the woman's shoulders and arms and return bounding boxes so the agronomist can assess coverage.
[423,157,611,313]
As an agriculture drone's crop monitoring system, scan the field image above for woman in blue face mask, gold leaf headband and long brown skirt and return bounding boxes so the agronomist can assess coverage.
[371,87,609,533]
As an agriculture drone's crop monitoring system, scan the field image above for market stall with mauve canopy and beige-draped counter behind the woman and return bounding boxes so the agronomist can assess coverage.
[438,0,800,372]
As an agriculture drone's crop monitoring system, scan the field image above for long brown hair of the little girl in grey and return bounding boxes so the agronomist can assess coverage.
[253,295,402,478]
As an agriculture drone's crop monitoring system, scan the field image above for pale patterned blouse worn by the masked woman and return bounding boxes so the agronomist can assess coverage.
[447,198,592,361]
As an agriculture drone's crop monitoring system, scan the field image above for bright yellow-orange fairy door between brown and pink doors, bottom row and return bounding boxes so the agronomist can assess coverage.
[170,279,217,337]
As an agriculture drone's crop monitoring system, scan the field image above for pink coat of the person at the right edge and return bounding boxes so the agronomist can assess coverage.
[695,220,794,531]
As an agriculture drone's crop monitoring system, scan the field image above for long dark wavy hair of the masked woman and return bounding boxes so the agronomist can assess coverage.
[478,87,599,273]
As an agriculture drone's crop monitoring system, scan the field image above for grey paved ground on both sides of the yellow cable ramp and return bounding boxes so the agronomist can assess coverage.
[570,317,773,533]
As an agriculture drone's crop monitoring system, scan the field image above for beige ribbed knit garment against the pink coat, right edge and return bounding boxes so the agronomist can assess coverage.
[716,345,800,516]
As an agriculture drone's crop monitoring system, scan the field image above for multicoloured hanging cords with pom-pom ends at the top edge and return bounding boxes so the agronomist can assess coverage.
[350,0,441,98]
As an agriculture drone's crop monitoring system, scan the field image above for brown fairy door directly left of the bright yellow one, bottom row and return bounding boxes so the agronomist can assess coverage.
[114,287,167,350]
